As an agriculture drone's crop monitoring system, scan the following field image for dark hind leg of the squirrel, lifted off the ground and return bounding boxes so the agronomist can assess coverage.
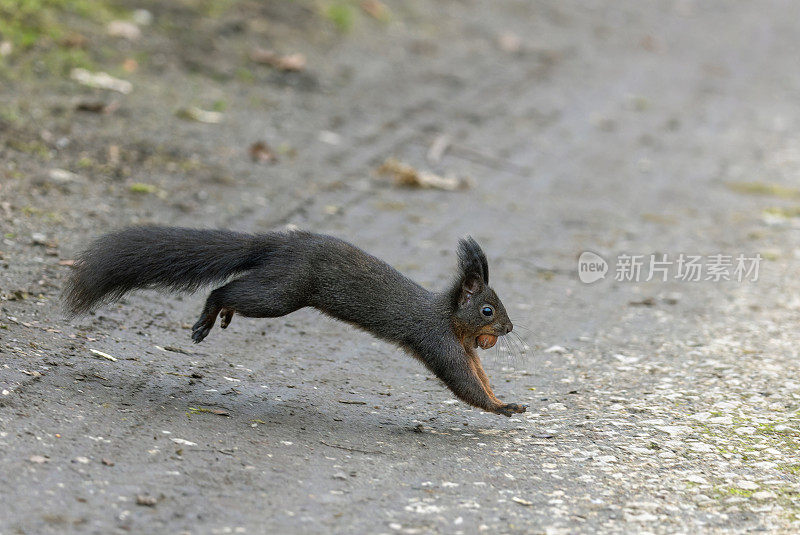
[192,274,305,343]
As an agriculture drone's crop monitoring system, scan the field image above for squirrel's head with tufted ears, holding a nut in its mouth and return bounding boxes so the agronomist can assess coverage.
[449,237,514,349]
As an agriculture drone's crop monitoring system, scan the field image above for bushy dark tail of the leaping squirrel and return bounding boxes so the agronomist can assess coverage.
[62,226,280,316]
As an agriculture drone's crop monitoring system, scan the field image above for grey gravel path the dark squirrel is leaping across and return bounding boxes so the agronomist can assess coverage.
[0,0,800,535]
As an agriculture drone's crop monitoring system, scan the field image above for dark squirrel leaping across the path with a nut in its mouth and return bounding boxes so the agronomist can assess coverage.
[63,226,527,416]
